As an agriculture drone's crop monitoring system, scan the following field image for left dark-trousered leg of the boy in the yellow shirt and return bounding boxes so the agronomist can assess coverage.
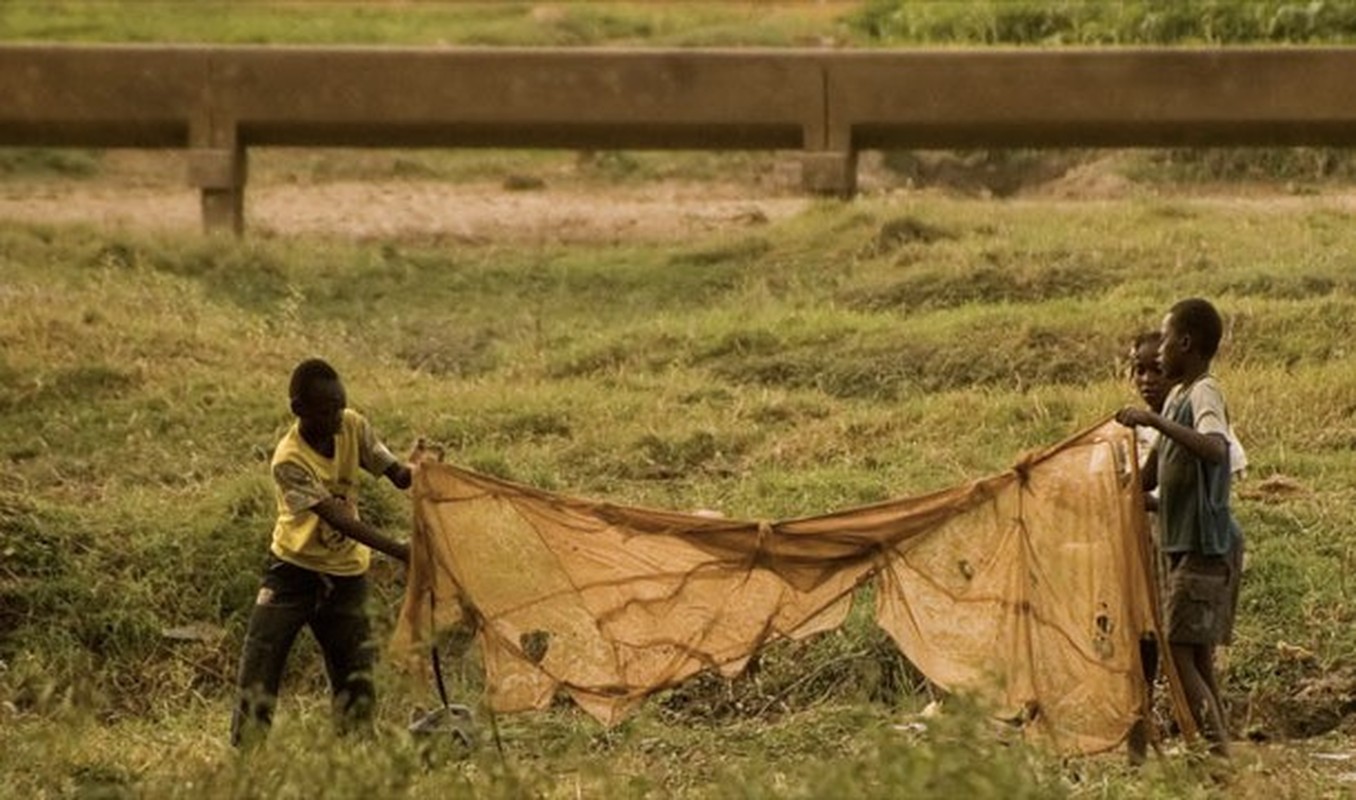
[231,560,315,747]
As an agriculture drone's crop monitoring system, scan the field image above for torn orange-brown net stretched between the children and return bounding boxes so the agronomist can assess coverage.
[392,420,1154,753]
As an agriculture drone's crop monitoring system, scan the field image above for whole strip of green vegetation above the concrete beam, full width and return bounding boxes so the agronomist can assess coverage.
[0,0,1356,47]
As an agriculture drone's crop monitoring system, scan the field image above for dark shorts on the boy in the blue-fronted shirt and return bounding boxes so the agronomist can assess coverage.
[1163,542,1243,645]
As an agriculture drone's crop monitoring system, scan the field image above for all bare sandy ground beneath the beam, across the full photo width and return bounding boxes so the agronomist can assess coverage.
[0,153,1356,243]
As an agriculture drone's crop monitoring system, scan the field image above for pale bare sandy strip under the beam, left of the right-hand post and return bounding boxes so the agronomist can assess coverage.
[0,182,811,241]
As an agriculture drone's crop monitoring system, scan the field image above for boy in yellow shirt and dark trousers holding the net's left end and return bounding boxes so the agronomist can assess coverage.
[231,358,411,746]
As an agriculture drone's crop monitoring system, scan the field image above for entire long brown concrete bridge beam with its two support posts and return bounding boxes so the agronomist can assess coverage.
[0,45,1356,232]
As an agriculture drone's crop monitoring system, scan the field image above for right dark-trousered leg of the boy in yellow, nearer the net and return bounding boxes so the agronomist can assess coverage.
[311,575,376,732]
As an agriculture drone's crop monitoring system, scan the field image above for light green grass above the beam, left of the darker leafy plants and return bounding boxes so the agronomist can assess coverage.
[0,0,852,46]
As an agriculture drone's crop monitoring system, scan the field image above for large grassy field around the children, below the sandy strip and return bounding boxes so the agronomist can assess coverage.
[0,198,1356,797]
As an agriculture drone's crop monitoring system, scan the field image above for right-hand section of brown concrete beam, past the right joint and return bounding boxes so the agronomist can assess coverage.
[826,49,1356,148]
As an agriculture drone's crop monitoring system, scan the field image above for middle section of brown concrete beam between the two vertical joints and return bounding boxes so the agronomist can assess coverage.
[212,49,824,149]
